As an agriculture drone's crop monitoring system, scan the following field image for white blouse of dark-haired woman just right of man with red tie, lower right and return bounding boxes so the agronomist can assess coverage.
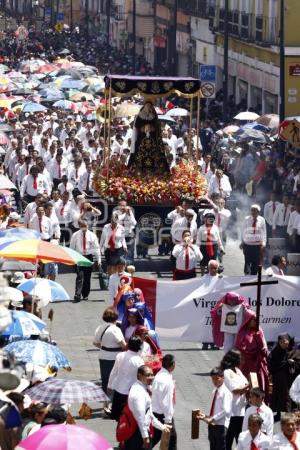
[224,368,248,416]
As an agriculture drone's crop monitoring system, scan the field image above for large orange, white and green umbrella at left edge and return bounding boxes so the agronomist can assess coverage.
[0,239,93,267]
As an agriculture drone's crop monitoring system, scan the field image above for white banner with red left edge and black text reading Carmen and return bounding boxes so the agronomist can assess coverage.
[134,275,300,342]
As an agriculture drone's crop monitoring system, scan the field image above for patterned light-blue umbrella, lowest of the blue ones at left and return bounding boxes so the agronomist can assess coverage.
[3,339,71,368]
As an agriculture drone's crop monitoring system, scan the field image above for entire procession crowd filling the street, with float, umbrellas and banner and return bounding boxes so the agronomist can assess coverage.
[0,19,300,450]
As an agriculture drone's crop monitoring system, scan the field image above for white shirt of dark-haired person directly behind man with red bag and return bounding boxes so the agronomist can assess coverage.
[108,350,144,395]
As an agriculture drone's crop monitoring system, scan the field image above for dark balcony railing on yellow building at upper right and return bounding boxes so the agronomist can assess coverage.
[215,8,279,47]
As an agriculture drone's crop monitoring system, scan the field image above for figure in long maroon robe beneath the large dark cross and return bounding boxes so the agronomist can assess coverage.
[235,310,269,397]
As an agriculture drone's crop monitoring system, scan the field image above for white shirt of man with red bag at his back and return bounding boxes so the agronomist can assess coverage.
[128,381,164,439]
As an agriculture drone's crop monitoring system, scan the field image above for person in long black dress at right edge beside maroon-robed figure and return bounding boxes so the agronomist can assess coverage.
[268,333,300,420]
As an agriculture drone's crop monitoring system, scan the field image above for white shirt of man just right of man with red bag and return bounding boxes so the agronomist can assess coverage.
[152,368,175,423]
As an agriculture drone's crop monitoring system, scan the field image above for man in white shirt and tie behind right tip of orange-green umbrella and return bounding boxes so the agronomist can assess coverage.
[70,220,101,303]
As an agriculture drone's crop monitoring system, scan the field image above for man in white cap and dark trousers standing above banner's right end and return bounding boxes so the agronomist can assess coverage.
[240,205,267,275]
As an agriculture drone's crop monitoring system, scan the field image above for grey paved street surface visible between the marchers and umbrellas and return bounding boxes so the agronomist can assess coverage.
[44,243,242,450]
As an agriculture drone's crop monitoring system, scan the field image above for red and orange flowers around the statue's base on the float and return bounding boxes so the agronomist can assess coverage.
[94,162,207,205]
